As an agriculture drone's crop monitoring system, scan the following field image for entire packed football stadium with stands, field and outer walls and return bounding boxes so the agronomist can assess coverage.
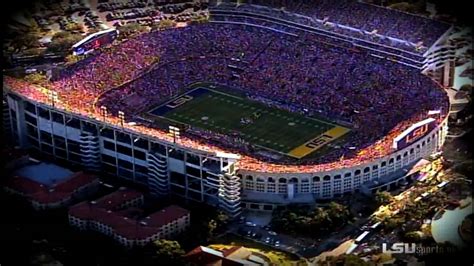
[4,1,454,217]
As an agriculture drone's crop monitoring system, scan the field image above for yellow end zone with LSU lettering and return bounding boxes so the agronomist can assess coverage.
[288,126,350,159]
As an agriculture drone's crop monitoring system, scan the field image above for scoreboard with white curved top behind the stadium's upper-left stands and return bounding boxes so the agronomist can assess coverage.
[72,29,118,55]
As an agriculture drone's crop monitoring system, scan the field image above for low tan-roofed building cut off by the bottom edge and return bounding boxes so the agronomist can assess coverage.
[184,246,269,266]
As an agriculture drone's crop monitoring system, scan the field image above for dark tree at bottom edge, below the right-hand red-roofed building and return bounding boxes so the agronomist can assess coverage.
[153,239,184,265]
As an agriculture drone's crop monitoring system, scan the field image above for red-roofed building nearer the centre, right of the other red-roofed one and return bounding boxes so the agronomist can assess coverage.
[69,188,190,247]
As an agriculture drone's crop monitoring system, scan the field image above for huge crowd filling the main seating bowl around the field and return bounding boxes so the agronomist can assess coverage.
[5,23,448,172]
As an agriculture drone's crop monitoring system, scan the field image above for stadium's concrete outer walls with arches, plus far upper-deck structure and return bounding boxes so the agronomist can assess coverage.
[3,2,454,217]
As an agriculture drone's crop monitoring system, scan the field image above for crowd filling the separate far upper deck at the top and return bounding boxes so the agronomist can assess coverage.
[217,0,450,52]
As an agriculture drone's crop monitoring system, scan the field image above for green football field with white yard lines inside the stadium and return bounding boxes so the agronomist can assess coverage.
[149,87,345,158]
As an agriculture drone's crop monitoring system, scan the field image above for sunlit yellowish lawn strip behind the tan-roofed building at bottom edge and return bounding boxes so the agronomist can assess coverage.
[209,234,306,265]
